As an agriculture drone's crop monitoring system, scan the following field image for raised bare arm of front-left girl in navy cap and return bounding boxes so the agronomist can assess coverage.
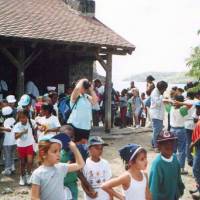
[68,141,85,172]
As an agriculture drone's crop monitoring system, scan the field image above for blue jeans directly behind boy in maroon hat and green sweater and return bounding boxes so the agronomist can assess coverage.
[170,127,186,168]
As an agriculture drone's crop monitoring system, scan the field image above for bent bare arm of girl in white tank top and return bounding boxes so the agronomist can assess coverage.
[102,174,130,200]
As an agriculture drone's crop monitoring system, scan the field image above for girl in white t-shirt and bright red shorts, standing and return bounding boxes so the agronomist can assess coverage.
[13,109,36,186]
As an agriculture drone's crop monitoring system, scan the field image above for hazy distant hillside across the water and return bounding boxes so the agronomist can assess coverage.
[124,72,194,83]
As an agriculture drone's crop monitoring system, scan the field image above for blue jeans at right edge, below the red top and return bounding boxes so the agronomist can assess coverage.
[193,146,200,188]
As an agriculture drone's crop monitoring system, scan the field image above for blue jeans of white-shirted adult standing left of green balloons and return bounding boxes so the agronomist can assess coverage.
[152,119,163,148]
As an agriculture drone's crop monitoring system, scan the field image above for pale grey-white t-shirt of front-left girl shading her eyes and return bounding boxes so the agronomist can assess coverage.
[31,163,68,200]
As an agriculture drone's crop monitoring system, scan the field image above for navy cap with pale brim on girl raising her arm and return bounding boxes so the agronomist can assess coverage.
[39,133,71,149]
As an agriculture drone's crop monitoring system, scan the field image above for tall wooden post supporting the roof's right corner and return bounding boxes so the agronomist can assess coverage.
[105,53,112,133]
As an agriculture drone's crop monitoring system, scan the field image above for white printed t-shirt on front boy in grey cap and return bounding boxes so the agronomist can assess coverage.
[83,158,112,200]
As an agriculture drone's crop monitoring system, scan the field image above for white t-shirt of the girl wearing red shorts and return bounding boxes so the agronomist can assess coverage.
[13,119,36,147]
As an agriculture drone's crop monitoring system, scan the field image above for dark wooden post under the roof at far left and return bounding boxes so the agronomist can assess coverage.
[17,47,26,98]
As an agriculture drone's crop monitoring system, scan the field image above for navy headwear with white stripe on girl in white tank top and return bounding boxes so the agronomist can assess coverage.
[119,144,144,162]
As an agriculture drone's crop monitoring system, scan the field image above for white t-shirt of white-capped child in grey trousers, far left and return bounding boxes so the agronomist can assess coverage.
[3,117,16,146]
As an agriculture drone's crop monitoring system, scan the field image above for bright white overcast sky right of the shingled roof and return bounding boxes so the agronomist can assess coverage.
[96,0,200,80]
